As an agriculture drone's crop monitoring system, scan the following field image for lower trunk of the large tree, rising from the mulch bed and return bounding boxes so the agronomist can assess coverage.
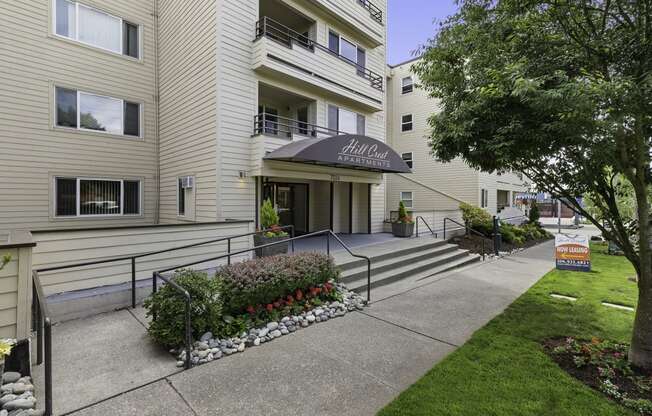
[629,284,652,370]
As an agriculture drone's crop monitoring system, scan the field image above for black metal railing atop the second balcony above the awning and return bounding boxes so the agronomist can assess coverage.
[255,16,383,91]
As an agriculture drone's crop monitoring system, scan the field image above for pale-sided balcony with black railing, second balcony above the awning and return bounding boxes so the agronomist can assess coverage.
[252,16,384,112]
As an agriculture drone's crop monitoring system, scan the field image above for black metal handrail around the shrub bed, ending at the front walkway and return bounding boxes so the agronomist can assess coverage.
[152,230,371,369]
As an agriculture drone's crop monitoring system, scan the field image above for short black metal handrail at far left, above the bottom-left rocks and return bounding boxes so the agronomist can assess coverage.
[32,270,52,416]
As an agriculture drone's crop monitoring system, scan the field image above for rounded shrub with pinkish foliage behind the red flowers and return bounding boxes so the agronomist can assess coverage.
[217,253,339,315]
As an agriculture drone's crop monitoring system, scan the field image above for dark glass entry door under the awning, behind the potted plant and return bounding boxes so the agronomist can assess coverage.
[263,182,308,235]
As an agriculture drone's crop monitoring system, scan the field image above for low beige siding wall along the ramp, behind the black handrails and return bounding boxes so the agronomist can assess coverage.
[32,222,253,294]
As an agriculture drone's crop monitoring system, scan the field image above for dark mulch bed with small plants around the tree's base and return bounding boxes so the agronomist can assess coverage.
[543,338,652,416]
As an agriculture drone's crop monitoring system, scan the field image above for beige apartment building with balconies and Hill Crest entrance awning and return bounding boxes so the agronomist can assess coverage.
[0,0,402,233]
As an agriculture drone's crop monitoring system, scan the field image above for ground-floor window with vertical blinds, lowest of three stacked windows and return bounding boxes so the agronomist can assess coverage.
[55,177,141,217]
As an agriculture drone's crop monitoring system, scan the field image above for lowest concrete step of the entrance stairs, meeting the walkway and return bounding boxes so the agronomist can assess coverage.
[342,249,480,290]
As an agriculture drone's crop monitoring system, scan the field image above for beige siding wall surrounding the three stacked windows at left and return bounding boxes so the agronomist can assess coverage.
[0,0,158,229]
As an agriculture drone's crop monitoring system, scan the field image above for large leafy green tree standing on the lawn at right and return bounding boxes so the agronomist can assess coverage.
[413,0,652,369]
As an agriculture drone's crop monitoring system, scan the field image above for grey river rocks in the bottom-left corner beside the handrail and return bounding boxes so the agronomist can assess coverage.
[0,371,45,416]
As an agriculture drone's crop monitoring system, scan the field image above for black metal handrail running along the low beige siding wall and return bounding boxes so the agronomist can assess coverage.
[33,225,294,308]
